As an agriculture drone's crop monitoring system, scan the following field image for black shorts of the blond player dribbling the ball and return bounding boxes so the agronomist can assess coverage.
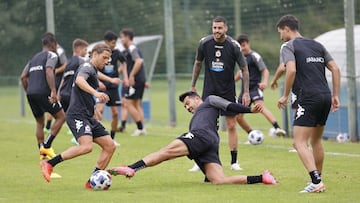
[66,114,109,139]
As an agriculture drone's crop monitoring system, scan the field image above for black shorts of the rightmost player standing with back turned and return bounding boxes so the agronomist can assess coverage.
[293,94,331,127]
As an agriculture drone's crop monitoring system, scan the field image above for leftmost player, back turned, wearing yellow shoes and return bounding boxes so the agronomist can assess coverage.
[21,35,65,160]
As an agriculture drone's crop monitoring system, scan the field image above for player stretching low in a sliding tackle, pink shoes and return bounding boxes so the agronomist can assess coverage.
[108,91,276,184]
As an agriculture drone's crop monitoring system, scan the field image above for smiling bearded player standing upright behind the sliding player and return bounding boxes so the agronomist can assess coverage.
[190,16,250,171]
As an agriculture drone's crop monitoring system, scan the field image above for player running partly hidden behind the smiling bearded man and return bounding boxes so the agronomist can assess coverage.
[235,34,286,137]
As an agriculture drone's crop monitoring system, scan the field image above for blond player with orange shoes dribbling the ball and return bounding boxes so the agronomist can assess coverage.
[40,43,120,188]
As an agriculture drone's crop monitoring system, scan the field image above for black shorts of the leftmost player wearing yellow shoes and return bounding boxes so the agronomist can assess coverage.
[26,94,62,118]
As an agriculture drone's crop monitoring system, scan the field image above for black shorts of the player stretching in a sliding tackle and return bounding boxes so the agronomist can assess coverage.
[177,131,221,174]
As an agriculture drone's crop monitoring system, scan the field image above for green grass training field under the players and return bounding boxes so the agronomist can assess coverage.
[0,79,360,203]
